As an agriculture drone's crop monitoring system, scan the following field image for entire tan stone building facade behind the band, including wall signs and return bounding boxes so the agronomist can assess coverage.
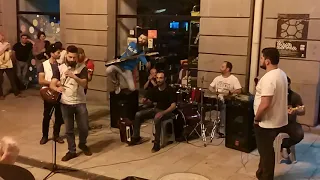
[0,0,320,126]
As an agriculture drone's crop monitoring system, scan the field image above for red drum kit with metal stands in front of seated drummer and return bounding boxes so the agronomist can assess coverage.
[170,81,228,146]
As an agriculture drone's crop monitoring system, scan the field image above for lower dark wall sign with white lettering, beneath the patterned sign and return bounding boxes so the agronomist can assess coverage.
[276,40,307,58]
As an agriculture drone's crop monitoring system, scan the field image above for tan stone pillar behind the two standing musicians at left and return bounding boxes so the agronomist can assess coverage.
[60,0,116,101]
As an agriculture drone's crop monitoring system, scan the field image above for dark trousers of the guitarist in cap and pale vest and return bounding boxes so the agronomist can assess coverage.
[42,101,63,137]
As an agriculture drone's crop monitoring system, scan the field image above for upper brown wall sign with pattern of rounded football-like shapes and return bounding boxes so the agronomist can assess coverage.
[277,14,309,39]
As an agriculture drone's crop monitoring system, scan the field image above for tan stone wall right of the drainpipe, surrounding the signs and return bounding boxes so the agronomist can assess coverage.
[259,0,320,126]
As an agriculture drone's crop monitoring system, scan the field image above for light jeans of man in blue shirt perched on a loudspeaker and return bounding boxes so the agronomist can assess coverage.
[106,65,135,91]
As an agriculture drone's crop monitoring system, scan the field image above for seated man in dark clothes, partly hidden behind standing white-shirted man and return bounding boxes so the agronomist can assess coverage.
[281,77,305,160]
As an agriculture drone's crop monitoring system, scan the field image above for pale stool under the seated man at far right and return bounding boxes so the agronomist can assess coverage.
[273,133,297,164]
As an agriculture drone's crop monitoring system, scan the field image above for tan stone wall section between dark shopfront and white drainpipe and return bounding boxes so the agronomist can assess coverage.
[198,0,251,88]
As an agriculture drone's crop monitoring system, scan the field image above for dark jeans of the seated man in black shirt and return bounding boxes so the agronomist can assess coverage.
[133,108,173,143]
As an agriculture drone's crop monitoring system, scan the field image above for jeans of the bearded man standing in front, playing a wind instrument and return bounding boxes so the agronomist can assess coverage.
[61,104,89,153]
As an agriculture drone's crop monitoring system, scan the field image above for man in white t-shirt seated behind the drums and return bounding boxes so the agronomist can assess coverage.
[209,61,241,137]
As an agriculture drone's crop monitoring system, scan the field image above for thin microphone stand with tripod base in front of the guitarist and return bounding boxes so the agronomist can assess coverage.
[43,107,77,180]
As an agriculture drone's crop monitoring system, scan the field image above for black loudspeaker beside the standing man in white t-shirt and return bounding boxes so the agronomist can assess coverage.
[225,96,257,153]
